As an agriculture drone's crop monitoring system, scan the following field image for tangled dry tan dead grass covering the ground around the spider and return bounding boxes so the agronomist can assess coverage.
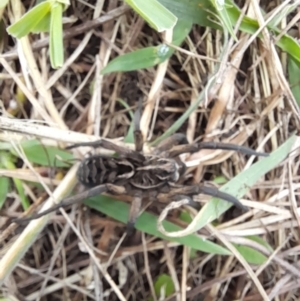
[0,1,300,301]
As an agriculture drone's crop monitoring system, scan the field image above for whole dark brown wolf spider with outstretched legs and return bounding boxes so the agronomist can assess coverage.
[15,102,268,230]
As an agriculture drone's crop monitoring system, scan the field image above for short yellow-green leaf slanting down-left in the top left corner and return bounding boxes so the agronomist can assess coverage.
[7,1,51,39]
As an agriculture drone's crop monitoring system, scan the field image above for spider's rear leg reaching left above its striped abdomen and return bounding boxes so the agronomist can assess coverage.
[66,139,145,162]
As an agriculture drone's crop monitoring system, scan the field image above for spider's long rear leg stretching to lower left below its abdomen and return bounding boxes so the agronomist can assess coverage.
[12,184,126,224]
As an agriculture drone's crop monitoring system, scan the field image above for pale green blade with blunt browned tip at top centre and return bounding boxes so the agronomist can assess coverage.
[125,0,177,32]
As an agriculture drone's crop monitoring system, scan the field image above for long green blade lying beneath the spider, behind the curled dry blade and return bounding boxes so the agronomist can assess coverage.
[84,195,230,255]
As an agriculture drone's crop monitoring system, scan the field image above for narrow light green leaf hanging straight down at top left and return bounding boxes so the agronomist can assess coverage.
[49,3,64,68]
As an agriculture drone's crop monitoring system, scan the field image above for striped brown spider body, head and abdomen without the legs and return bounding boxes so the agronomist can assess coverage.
[77,155,185,199]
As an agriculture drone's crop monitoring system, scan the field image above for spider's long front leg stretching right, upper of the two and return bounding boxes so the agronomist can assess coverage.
[168,141,269,158]
